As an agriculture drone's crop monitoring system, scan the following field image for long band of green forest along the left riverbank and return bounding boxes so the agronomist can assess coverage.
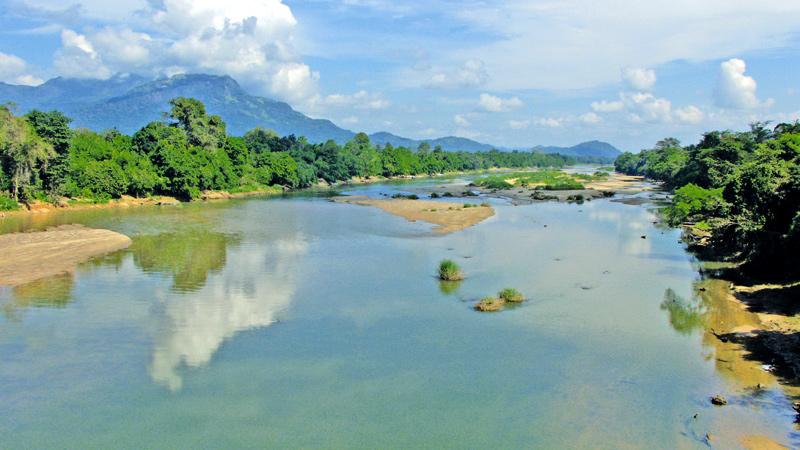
[0,98,575,209]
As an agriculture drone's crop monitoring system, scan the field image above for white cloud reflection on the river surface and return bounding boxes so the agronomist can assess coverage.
[150,234,307,390]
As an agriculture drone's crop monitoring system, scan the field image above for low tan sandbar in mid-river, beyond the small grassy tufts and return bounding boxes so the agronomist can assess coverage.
[334,197,494,233]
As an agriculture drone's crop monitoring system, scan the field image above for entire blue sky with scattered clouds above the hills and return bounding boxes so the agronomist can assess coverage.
[0,0,800,150]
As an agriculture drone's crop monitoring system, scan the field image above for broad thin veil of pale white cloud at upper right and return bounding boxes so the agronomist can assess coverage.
[446,0,800,91]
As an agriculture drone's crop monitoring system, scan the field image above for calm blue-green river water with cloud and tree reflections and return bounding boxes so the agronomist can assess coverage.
[0,181,800,448]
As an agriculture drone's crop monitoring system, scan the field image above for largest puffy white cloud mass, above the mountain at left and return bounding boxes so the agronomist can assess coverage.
[47,0,318,105]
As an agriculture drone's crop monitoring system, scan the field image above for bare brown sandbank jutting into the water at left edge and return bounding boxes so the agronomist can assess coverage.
[0,225,131,286]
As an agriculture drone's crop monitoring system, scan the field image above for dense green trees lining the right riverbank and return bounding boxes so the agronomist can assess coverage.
[615,122,800,277]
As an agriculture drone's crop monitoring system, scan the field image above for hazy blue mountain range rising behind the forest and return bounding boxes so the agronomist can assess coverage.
[0,74,620,160]
